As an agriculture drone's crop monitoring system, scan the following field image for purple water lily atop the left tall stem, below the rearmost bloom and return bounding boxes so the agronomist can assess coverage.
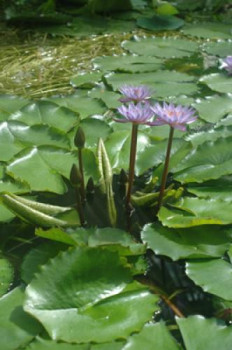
[114,102,156,125]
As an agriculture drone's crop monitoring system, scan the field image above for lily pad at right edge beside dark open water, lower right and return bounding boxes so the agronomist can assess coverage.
[186,259,232,300]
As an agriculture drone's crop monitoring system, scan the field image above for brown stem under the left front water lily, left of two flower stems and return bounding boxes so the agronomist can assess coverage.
[126,123,138,209]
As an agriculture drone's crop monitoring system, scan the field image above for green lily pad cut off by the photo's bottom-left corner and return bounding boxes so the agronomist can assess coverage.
[0,288,41,350]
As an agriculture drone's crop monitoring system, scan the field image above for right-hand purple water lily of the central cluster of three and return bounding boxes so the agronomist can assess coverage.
[150,102,197,131]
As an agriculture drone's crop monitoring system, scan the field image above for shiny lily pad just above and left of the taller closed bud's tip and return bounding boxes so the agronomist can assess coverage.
[9,101,78,132]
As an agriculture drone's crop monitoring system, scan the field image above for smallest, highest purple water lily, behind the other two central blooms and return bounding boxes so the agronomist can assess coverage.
[119,85,151,103]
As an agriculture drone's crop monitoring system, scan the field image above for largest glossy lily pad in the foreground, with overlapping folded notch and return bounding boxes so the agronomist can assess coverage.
[25,248,157,343]
